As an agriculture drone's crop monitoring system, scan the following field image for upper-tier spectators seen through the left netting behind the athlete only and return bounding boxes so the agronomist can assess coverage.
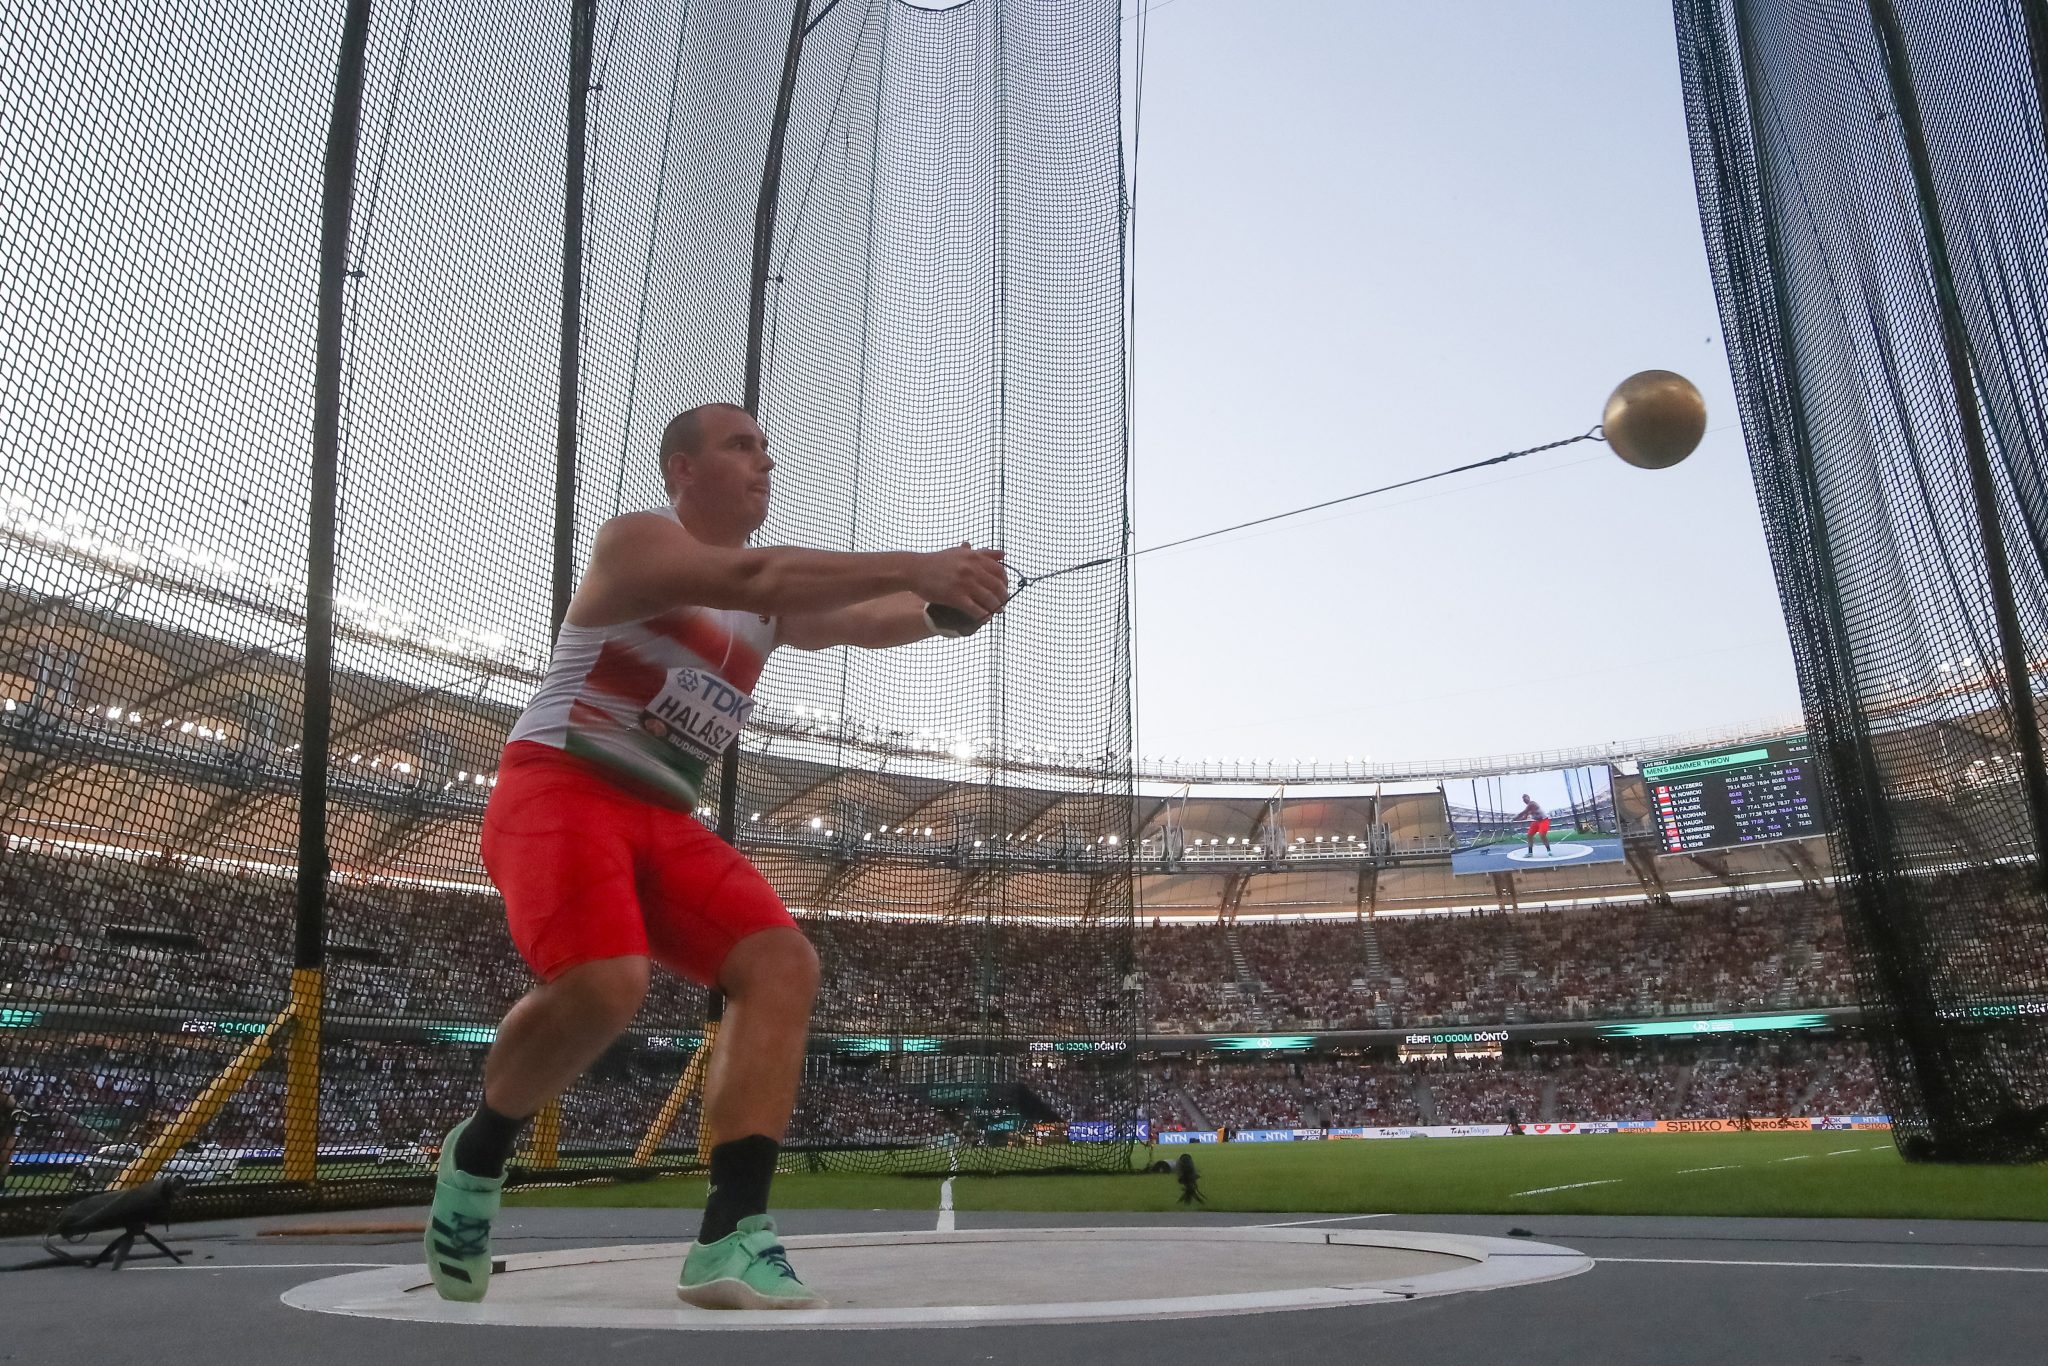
[0,848,1143,1034]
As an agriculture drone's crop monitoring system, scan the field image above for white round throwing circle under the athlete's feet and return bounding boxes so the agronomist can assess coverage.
[283,1227,1593,1329]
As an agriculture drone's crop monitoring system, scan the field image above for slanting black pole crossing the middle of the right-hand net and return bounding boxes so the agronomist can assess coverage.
[1870,0,2048,887]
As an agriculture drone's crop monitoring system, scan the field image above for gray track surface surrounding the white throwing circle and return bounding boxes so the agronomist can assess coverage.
[0,1208,2048,1366]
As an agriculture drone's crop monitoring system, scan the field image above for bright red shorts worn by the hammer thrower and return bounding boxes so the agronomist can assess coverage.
[483,739,797,987]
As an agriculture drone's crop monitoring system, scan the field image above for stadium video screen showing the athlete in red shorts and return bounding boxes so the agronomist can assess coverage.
[1444,764,1622,872]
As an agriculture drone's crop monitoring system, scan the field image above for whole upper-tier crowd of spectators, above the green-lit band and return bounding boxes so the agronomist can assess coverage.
[0,848,1900,1034]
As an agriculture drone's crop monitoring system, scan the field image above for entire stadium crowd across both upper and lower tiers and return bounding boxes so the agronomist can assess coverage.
[0,846,1933,1179]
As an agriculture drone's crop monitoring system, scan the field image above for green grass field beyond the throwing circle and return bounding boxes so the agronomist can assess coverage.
[506,1130,2048,1219]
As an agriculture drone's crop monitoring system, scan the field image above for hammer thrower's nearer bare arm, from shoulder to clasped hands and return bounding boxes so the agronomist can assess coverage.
[569,512,1008,627]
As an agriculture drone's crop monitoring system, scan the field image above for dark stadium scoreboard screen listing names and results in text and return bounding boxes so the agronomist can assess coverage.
[1642,735,1827,854]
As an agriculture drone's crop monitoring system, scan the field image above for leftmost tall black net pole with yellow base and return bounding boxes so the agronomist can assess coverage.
[285,0,371,1182]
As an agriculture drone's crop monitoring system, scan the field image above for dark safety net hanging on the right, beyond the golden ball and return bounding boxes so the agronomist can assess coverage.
[1677,0,2048,1161]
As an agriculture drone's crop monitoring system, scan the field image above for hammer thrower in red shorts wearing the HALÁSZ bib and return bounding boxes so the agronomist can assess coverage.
[426,403,1008,1309]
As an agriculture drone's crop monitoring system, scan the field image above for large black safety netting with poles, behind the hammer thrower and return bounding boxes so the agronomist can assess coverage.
[0,0,1141,1227]
